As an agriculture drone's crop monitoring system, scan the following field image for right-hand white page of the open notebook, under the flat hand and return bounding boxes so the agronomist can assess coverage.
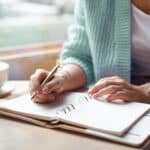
[56,94,150,135]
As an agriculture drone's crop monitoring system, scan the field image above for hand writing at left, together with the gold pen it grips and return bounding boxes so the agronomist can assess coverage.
[30,62,68,103]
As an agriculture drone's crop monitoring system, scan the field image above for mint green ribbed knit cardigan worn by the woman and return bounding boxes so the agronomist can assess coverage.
[60,0,131,84]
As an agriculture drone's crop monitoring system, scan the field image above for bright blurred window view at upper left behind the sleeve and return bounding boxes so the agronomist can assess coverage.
[0,0,75,50]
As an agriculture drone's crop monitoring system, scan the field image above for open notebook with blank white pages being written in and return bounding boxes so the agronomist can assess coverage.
[0,92,150,136]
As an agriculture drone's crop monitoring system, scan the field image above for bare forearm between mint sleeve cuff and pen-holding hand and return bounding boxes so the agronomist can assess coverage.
[60,64,87,91]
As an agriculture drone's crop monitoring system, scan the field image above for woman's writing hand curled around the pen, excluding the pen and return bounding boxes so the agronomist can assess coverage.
[30,69,65,103]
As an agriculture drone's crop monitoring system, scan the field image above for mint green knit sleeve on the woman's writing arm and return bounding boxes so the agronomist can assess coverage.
[60,0,94,84]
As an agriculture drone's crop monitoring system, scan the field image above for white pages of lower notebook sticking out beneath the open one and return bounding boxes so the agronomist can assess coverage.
[84,112,150,147]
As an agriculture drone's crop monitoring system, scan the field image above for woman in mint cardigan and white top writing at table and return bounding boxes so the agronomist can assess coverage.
[30,0,150,103]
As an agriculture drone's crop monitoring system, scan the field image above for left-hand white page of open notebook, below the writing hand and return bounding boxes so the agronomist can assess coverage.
[0,94,77,121]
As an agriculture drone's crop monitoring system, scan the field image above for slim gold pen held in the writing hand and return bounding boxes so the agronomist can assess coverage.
[31,61,62,99]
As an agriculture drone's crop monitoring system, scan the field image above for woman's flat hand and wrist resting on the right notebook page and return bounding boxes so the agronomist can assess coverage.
[88,76,150,102]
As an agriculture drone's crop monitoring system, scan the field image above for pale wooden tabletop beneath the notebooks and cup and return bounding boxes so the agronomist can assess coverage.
[0,81,150,150]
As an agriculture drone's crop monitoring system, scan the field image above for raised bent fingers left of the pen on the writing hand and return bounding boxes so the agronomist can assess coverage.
[29,69,48,93]
